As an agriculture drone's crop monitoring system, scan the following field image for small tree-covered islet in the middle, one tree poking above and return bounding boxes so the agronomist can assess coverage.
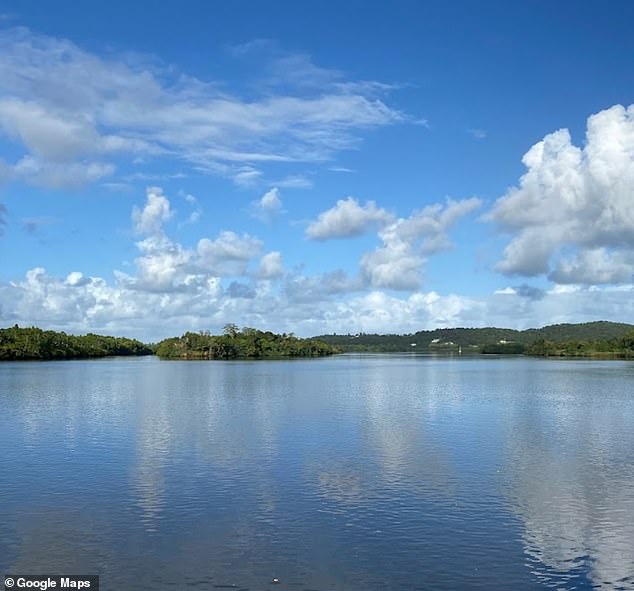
[156,324,340,359]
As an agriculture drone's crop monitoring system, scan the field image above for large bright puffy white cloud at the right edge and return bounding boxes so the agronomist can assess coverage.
[488,105,634,284]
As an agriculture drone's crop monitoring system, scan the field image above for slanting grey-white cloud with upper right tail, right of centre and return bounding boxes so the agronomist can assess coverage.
[361,197,481,290]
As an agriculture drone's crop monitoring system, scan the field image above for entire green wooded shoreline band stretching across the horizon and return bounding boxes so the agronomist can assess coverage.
[6,322,634,361]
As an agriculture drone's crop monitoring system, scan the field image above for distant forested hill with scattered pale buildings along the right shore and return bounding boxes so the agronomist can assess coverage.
[314,321,634,352]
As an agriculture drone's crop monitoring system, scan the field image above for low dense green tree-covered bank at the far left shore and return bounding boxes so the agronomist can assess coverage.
[0,324,153,360]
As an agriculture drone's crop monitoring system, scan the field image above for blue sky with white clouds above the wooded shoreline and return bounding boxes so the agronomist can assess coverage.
[0,0,634,341]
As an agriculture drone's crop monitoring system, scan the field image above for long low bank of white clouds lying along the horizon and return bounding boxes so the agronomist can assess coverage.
[0,268,634,340]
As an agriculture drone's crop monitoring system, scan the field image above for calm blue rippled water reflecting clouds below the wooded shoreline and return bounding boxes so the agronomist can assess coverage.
[0,355,634,591]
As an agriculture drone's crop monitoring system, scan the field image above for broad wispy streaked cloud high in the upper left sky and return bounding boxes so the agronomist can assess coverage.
[0,28,405,187]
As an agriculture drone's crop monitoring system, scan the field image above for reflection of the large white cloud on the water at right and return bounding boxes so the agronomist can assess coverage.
[506,374,634,591]
